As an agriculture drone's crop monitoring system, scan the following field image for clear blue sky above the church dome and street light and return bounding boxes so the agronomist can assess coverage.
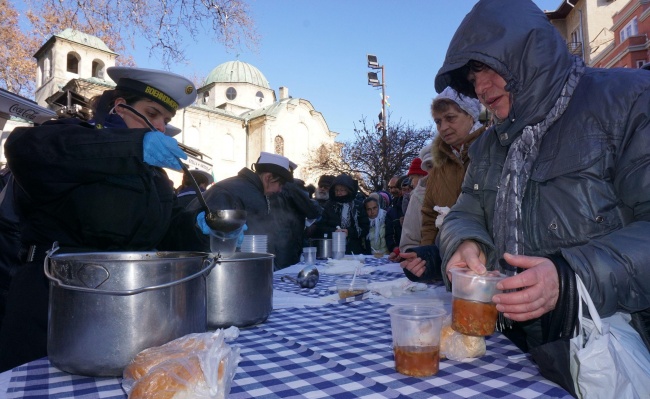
[134,0,562,142]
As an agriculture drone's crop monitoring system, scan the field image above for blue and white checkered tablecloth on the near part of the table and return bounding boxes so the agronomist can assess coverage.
[7,301,571,399]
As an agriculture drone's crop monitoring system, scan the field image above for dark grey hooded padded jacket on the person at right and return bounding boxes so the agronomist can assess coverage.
[435,0,650,344]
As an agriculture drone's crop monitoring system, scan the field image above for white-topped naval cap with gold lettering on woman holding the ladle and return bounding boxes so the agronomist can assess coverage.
[106,67,196,113]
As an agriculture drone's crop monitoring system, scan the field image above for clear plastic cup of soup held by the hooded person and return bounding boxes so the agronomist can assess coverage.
[451,269,506,337]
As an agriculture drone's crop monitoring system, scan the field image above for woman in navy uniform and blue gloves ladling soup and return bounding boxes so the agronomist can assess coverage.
[0,67,207,371]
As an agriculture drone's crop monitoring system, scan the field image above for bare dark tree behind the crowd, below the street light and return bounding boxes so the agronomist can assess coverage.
[305,117,433,193]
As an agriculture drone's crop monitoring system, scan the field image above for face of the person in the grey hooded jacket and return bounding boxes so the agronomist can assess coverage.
[467,67,512,120]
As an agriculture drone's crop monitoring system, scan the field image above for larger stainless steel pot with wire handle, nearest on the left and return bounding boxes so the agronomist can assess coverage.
[44,252,214,377]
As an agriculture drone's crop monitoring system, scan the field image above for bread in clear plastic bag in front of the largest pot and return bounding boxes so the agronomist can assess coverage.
[122,327,240,399]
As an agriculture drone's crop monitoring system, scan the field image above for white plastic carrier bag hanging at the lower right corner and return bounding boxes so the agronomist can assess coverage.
[570,276,650,399]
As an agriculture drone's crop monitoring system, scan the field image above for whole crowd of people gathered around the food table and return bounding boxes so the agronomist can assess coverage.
[0,0,650,389]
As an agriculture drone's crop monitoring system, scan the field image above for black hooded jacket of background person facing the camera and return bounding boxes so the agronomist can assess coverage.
[312,174,370,255]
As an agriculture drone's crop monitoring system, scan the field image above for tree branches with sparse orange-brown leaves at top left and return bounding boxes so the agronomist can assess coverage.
[0,0,259,96]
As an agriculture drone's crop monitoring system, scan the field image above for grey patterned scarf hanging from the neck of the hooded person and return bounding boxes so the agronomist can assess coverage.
[493,57,585,270]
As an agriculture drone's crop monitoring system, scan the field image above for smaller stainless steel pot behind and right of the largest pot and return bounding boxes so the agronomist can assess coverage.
[208,252,274,330]
